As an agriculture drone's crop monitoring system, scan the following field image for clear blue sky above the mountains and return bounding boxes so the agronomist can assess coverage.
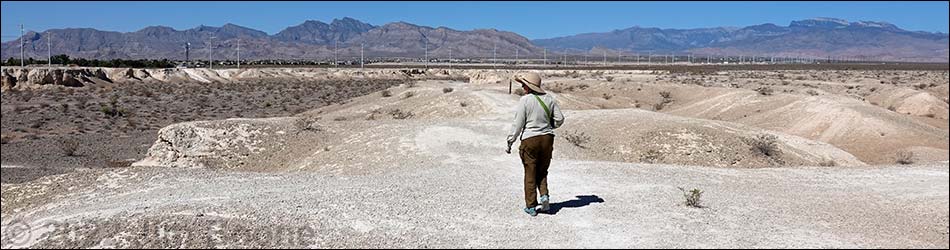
[0,1,950,41]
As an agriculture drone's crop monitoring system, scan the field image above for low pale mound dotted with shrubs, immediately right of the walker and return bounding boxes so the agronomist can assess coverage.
[557,109,864,168]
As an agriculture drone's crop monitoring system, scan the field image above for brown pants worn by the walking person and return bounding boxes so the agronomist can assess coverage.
[519,135,554,208]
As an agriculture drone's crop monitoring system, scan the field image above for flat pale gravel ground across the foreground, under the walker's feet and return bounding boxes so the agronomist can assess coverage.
[3,160,950,248]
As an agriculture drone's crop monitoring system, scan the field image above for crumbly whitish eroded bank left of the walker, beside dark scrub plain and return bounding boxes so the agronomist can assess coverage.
[134,117,321,170]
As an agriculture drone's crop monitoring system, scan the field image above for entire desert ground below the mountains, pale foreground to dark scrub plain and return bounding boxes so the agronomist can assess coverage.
[0,67,950,248]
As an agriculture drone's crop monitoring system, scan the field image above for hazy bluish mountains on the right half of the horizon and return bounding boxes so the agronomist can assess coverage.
[533,18,950,62]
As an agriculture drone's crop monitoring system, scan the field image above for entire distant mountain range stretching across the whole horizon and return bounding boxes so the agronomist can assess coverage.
[0,18,950,62]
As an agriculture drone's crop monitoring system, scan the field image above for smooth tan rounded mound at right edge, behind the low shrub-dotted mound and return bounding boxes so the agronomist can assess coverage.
[670,91,948,164]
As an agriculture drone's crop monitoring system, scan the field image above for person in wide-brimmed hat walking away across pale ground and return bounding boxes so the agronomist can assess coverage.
[505,72,564,216]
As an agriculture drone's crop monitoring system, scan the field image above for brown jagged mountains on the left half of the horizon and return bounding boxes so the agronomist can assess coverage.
[0,18,542,60]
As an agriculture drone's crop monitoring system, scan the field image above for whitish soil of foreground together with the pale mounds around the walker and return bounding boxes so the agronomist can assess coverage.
[0,72,950,248]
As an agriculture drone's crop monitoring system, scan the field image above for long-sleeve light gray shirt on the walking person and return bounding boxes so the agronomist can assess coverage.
[508,93,564,144]
